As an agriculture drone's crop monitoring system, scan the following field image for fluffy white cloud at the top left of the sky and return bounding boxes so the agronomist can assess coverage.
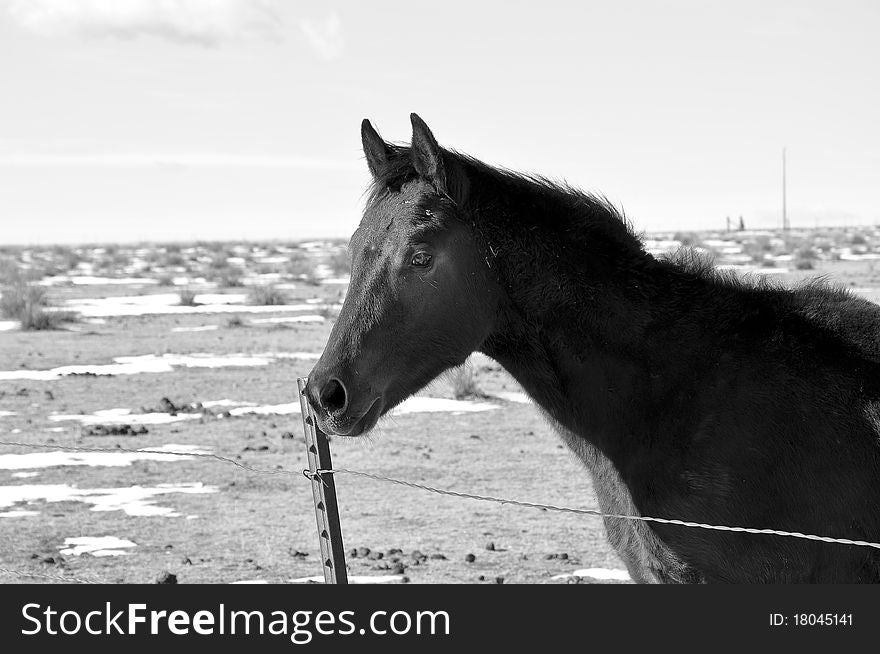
[9,0,284,46]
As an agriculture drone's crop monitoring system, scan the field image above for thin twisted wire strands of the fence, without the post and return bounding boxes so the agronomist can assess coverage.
[0,440,880,583]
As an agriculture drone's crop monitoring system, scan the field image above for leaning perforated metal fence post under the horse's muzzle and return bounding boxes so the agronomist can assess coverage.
[296,377,348,584]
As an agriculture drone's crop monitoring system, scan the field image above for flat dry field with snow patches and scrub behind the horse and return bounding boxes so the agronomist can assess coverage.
[0,228,880,583]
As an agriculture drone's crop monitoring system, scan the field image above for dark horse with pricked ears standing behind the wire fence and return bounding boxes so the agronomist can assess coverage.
[305,114,880,583]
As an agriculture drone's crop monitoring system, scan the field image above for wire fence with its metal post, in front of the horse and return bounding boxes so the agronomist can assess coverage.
[0,378,880,584]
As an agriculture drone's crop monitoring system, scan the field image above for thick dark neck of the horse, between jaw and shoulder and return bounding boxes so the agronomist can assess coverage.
[470,179,706,460]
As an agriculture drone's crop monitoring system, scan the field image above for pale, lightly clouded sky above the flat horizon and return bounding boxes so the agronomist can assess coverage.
[0,0,880,244]
